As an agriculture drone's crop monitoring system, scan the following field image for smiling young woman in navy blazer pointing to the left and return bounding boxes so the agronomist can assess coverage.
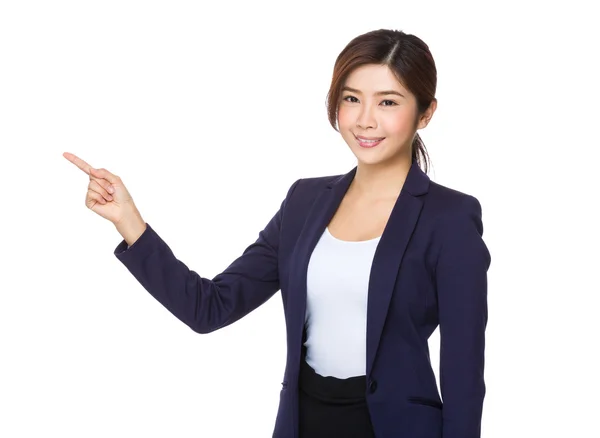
[65,30,491,438]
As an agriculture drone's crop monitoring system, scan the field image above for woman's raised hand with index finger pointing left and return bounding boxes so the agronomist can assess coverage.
[63,152,141,226]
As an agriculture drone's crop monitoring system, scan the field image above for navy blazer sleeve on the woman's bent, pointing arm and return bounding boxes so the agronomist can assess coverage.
[114,180,300,333]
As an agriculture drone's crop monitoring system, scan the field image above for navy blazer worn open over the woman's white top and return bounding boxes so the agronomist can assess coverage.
[114,162,491,438]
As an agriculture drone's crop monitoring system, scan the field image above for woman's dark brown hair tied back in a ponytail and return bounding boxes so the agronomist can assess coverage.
[327,29,437,173]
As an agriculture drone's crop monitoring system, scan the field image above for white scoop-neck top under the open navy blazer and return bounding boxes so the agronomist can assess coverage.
[304,228,381,379]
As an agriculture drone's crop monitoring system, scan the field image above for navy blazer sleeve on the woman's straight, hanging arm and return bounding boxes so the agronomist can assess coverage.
[436,195,491,438]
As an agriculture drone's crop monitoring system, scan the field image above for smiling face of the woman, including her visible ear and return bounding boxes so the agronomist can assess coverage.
[338,64,435,164]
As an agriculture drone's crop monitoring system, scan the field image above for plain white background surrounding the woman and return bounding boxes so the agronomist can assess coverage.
[0,0,600,438]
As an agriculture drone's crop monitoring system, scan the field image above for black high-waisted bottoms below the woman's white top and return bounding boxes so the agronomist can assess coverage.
[299,355,375,438]
